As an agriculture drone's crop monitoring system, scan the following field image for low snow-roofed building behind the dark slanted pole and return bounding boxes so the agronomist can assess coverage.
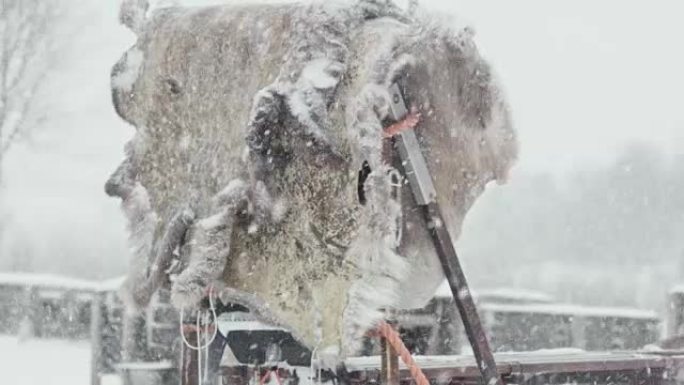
[365,282,664,354]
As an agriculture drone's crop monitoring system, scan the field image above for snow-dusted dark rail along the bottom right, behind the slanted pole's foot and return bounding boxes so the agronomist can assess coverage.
[345,349,684,385]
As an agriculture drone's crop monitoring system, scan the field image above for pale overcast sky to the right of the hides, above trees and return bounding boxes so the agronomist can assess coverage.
[439,0,684,171]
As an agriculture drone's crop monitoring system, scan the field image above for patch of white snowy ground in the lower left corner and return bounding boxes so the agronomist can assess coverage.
[0,336,90,385]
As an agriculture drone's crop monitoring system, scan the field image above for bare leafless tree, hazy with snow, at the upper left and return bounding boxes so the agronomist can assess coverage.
[0,0,60,176]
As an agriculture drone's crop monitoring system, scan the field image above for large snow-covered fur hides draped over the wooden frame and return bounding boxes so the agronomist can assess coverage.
[107,0,517,355]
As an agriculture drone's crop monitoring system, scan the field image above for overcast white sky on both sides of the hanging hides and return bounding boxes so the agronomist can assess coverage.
[0,0,684,275]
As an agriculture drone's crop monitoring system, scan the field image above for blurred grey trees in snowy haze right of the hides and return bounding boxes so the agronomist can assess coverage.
[460,142,684,308]
